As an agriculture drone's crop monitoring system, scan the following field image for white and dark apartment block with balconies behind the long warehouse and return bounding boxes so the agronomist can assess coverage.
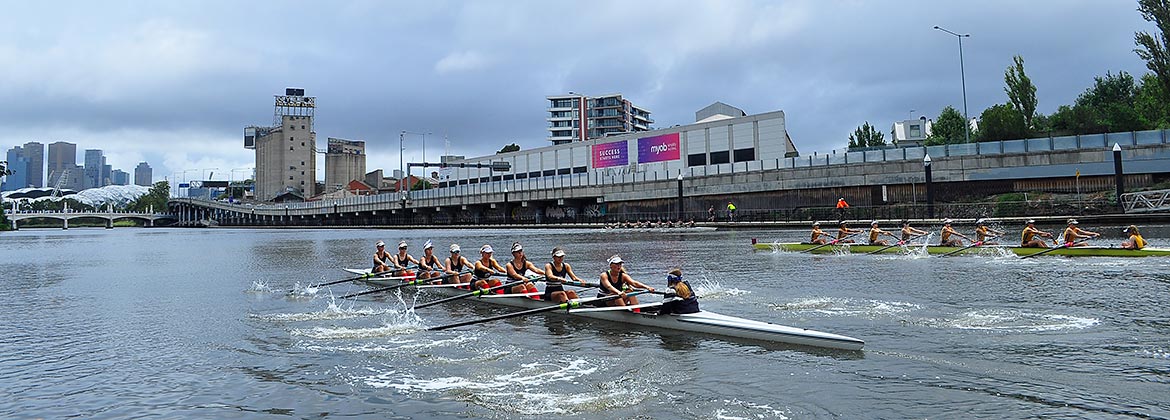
[545,92,654,144]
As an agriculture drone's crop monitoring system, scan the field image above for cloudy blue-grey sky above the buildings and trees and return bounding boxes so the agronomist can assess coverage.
[0,0,1155,184]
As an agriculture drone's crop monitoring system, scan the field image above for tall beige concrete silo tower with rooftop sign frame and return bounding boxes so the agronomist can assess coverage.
[243,88,317,201]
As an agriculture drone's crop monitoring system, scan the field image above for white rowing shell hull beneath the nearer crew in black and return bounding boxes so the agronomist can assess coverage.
[345,268,866,351]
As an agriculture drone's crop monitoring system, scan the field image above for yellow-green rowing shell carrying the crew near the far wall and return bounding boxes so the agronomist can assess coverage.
[755,242,1170,256]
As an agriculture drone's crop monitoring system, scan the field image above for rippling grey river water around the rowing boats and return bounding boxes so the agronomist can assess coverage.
[0,227,1170,419]
